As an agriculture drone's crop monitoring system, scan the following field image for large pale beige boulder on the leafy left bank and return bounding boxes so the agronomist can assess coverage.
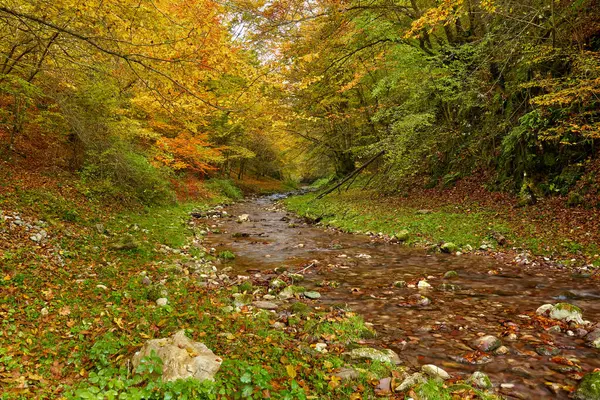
[131,330,223,381]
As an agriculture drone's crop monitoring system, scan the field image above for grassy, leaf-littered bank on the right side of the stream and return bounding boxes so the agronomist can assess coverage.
[286,179,600,265]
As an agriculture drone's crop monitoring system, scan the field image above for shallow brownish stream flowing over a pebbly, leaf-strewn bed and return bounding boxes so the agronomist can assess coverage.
[200,196,600,399]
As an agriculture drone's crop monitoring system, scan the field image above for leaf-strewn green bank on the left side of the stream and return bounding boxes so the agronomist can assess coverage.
[0,171,496,400]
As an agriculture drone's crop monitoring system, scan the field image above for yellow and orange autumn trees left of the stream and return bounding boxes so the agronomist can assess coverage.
[0,0,288,201]
